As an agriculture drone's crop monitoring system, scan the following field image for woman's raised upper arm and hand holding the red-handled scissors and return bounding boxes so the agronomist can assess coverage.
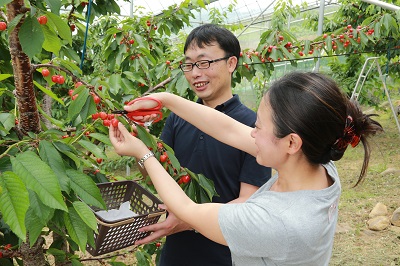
[125,92,256,156]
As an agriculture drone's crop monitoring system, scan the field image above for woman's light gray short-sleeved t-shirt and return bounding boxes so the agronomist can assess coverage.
[218,162,341,266]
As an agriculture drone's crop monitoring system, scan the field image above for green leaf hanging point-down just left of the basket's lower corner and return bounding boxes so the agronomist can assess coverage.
[64,208,88,250]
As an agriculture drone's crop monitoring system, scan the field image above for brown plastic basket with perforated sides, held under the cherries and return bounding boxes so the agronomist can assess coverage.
[87,181,165,256]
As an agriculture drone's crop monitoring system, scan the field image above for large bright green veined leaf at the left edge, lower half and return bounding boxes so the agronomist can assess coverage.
[0,172,29,241]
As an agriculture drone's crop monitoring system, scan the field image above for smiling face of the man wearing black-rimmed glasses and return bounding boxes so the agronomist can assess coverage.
[184,42,236,104]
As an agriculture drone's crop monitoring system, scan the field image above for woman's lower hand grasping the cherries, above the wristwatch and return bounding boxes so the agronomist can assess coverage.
[109,123,149,158]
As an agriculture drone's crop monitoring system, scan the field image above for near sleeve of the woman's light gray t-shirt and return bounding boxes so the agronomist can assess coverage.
[218,202,289,258]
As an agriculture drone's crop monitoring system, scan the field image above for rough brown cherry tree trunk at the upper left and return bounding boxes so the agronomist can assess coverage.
[7,0,41,133]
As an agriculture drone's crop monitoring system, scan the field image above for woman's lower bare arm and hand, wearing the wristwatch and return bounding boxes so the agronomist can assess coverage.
[109,123,226,245]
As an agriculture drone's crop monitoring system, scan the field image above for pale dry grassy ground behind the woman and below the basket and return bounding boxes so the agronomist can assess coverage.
[76,101,400,266]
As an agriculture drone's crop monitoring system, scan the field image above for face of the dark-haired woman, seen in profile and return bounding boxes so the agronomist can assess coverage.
[251,94,287,169]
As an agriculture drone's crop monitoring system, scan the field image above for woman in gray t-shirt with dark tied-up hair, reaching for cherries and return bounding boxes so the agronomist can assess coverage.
[110,72,382,266]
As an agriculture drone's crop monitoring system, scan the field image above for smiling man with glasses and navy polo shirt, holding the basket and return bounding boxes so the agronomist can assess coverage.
[136,24,271,266]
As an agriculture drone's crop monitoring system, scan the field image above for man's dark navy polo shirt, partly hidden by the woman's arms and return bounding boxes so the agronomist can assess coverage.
[160,95,271,266]
